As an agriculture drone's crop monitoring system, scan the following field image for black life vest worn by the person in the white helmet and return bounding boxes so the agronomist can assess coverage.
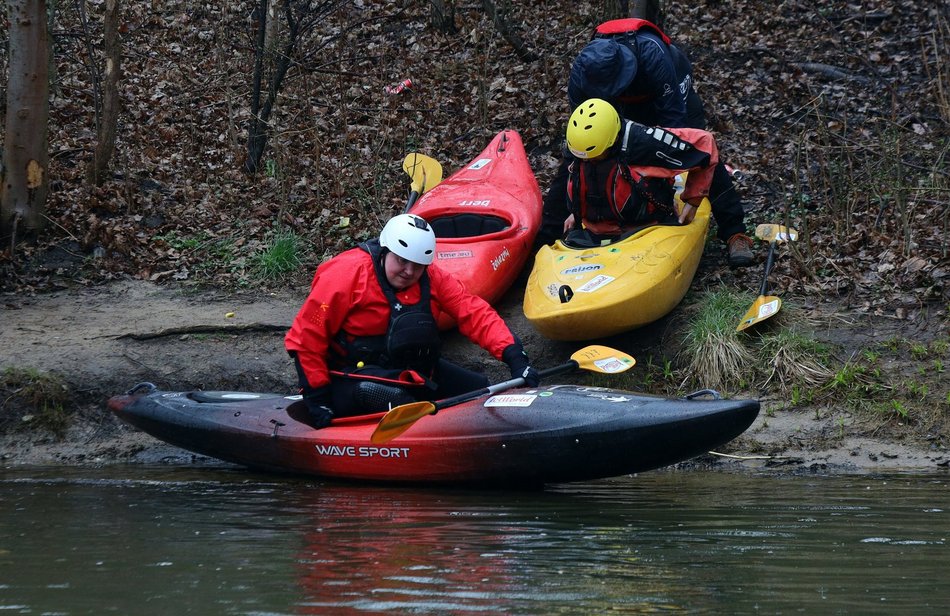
[333,239,441,375]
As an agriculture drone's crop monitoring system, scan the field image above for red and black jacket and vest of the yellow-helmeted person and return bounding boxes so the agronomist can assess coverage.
[567,120,719,235]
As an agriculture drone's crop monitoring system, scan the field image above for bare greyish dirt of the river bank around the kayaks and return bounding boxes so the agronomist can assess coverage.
[0,281,950,473]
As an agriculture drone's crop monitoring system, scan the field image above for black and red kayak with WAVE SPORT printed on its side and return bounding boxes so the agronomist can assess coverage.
[109,383,759,486]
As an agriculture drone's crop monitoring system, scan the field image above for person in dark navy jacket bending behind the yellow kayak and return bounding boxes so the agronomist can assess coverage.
[536,18,753,267]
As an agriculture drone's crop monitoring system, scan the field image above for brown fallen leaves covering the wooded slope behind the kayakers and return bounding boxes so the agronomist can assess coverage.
[3,0,950,318]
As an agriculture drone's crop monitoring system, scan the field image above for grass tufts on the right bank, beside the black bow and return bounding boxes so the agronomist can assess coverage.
[585,288,950,435]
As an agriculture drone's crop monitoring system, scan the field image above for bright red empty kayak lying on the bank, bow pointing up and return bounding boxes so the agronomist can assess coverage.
[410,130,541,329]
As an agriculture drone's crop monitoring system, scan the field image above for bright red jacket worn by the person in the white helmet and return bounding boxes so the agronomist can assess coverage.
[284,240,515,388]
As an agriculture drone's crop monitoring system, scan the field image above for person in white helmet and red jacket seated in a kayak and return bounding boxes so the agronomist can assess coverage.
[284,214,539,427]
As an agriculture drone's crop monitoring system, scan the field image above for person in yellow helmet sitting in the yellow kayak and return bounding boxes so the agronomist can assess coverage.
[564,98,719,243]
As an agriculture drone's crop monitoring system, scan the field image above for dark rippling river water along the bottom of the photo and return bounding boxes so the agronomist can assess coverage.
[0,466,950,615]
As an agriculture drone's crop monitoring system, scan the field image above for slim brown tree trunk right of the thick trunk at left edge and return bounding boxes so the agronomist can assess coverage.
[86,0,122,186]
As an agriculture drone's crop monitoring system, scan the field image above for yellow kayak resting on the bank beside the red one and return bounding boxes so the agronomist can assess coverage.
[524,199,710,340]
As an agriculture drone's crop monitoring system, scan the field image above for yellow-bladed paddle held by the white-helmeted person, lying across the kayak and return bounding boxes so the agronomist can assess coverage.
[370,344,637,443]
